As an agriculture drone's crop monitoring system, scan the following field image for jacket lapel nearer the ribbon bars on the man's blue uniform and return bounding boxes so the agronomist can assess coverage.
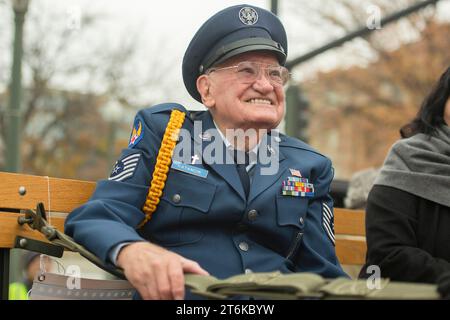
[248,135,288,203]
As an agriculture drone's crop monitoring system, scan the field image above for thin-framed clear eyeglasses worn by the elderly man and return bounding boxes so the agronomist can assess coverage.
[206,61,290,86]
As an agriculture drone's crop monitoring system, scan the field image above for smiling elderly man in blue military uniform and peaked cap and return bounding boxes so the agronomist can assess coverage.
[66,5,345,299]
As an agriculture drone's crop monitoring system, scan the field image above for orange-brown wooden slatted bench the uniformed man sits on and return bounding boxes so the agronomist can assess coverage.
[0,172,366,299]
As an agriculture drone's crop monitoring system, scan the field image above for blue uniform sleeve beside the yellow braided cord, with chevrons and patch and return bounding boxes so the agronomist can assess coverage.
[65,110,168,263]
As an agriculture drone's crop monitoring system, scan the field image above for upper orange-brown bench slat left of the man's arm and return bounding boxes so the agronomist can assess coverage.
[0,172,95,212]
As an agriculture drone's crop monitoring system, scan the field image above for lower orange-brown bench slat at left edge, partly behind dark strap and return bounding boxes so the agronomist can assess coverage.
[0,211,65,248]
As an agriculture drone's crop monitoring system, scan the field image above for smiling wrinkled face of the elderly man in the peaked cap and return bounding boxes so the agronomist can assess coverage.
[197,51,284,132]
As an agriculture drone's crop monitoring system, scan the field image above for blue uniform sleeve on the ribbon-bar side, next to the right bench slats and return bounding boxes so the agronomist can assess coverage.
[299,159,348,278]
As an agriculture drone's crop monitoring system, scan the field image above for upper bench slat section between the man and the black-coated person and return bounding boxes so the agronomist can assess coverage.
[334,208,366,236]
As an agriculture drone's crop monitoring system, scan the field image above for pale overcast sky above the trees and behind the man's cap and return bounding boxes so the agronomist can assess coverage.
[0,0,450,109]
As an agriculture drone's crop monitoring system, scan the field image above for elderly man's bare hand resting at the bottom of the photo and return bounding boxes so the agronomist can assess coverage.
[117,242,208,300]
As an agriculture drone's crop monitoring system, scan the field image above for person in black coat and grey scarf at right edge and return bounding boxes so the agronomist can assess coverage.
[360,68,450,283]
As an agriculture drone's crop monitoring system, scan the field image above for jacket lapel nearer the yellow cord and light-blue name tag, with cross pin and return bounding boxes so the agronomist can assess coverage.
[191,111,246,201]
